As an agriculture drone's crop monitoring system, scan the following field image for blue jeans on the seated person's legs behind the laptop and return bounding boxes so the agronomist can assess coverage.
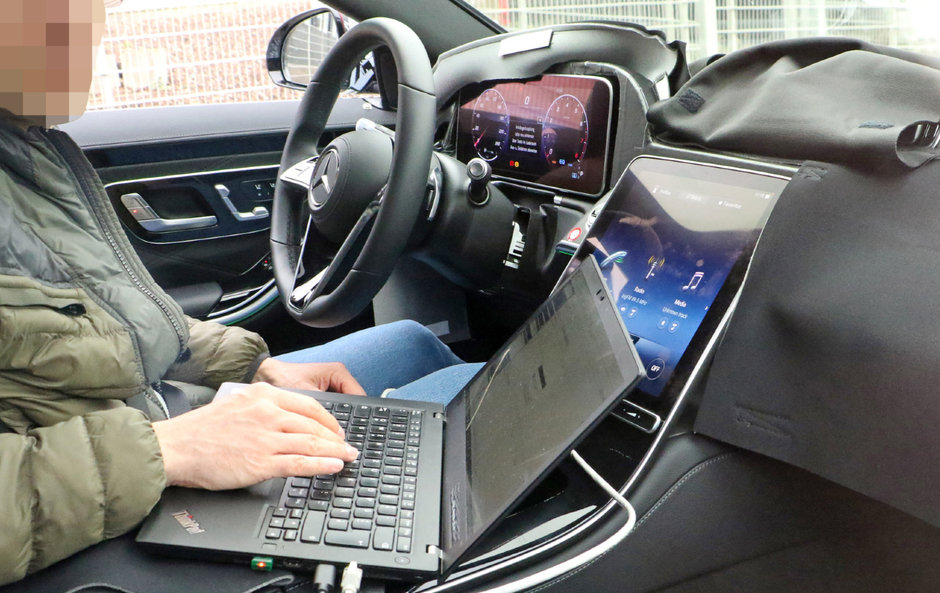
[277,321,483,404]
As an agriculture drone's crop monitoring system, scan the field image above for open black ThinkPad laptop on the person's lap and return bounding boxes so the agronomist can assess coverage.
[137,258,644,580]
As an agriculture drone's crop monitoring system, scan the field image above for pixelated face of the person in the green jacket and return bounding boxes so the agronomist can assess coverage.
[0,0,107,126]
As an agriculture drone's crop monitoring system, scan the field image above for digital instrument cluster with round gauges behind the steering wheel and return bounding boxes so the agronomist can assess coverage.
[457,75,612,195]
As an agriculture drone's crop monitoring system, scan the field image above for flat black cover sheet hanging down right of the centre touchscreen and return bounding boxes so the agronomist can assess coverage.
[695,161,940,525]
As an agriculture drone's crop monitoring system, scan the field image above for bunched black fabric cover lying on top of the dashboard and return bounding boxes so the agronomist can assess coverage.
[648,38,940,167]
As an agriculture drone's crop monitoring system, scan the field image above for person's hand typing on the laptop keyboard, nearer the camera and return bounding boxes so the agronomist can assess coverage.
[153,383,359,490]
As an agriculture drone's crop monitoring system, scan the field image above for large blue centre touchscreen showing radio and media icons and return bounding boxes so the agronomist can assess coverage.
[586,158,786,396]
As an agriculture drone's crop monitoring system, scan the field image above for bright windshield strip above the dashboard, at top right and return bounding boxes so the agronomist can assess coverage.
[460,0,940,60]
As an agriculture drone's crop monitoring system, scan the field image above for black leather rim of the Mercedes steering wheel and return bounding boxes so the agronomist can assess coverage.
[271,18,436,327]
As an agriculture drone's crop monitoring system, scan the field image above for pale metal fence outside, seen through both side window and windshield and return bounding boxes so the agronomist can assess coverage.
[90,0,940,109]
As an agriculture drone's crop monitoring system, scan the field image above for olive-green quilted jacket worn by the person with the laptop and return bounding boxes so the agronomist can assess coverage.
[0,112,267,584]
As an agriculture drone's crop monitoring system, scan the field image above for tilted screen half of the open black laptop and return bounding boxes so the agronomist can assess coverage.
[441,259,642,574]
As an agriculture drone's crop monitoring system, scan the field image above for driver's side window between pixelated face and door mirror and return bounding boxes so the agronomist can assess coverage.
[89,0,338,109]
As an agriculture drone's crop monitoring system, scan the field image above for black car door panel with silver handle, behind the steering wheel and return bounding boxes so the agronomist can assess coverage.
[63,98,394,346]
